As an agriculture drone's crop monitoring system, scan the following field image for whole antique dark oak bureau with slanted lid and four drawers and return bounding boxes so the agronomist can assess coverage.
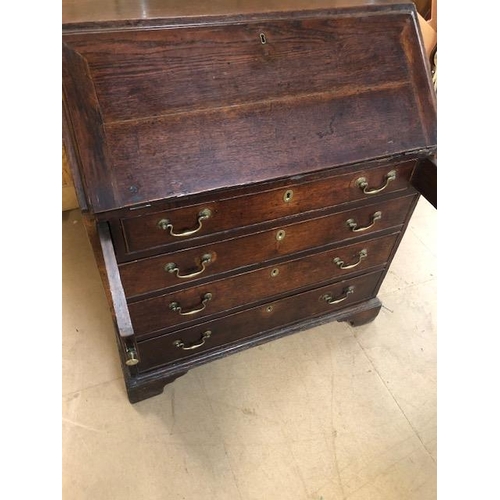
[63,0,436,402]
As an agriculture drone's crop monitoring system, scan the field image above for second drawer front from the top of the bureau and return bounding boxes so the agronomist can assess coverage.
[119,195,416,298]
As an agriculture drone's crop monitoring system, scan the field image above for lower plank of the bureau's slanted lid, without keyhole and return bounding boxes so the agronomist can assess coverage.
[106,86,428,208]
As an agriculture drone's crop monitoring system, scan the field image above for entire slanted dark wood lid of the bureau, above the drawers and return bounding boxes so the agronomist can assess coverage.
[64,4,436,213]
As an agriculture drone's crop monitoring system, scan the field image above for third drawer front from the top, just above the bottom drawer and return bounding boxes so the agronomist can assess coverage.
[129,233,399,336]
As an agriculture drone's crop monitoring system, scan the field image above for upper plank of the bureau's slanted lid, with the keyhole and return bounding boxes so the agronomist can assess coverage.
[65,14,408,123]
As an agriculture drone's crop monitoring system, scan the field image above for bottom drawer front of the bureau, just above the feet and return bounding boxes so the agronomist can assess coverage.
[137,272,382,372]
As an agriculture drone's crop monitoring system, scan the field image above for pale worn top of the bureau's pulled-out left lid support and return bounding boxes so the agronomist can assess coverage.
[97,222,134,337]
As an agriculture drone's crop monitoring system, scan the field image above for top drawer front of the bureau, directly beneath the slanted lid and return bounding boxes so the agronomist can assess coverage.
[121,160,415,253]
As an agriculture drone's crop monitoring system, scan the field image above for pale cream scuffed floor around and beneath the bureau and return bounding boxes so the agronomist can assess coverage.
[63,199,436,500]
